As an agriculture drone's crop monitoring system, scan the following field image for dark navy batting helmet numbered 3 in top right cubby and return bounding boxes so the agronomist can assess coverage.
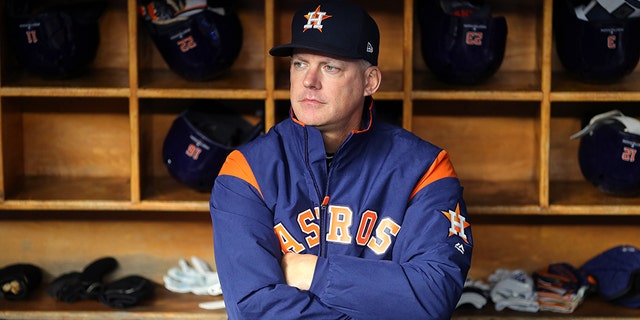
[553,0,640,83]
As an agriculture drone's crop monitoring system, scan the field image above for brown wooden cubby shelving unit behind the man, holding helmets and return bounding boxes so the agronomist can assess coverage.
[0,0,640,319]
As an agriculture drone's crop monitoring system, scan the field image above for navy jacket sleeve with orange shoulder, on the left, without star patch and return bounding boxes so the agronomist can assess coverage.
[210,152,348,319]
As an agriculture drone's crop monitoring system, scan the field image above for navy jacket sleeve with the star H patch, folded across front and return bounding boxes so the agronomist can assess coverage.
[310,151,472,319]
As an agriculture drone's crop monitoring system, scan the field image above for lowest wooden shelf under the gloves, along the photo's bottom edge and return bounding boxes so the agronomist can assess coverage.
[0,285,640,320]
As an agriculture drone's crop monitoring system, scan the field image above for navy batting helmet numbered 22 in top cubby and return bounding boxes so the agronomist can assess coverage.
[140,0,243,81]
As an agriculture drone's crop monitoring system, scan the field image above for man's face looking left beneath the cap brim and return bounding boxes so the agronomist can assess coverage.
[289,51,367,132]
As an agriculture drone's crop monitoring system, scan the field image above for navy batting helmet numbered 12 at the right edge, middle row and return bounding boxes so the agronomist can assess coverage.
[571,110,640,196]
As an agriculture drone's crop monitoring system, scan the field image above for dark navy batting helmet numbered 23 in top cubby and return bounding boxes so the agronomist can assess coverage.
[418,0,507,84]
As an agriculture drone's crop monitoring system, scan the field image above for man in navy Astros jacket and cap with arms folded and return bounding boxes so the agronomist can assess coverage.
[211,1,473,319]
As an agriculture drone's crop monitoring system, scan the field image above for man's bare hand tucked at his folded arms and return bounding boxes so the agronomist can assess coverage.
[281,253,318,290]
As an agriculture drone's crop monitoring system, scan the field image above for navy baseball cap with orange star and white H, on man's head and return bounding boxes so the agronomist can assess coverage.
[269,1,380,66]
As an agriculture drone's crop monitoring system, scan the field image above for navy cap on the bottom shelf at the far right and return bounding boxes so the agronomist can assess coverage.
[581,245,640,308]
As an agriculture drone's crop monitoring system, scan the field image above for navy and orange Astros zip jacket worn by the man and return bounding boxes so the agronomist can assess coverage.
[210,99,473,319]
